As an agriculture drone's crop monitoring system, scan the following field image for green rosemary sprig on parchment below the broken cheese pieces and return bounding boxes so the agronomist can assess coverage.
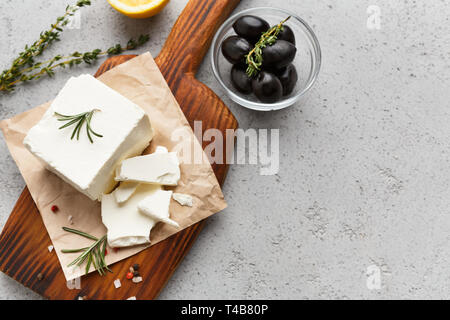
[61,227,112,275]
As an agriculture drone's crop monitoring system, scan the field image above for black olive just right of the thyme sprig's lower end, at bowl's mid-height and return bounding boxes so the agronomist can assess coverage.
[262,40,297,69]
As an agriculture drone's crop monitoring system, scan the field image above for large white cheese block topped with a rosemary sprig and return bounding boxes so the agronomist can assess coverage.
[23,75,153,200]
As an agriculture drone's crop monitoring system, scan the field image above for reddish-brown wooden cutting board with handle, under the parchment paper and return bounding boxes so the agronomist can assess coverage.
[0,0,240,300]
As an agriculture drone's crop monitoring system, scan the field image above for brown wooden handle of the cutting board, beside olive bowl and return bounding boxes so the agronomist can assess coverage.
[157,0,240,77]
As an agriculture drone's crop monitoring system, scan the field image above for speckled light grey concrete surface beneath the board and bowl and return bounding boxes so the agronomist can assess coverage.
[0,0,450,299]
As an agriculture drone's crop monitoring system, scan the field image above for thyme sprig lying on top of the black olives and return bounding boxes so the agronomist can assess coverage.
[246,16,291,78]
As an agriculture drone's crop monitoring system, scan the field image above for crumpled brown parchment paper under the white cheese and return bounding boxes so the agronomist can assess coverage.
[0,53,226,280]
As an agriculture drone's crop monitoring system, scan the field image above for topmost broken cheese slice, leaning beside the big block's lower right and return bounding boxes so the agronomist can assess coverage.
[116,152,180,186]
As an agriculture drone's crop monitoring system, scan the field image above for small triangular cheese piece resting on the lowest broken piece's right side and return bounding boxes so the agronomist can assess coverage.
[138,190,180,228]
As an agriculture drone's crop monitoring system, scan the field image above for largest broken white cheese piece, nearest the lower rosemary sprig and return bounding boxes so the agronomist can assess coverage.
[102,184,161,248]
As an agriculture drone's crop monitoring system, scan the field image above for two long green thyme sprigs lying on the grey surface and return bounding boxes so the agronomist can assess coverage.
[0,0,149,92]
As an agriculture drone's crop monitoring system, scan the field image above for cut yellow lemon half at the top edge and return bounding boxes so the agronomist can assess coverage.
[108,0,170,19]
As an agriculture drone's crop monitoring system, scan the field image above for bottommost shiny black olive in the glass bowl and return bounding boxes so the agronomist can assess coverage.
[252,71,283,103]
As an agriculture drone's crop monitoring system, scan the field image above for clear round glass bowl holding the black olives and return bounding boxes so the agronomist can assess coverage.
[211,7,321,111]
